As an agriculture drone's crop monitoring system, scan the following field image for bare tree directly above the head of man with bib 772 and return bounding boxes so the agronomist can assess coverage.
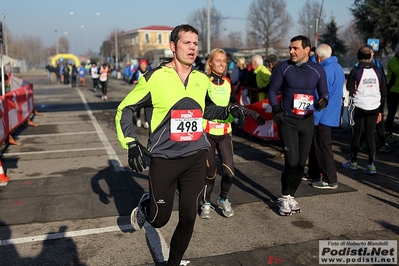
[298,0,326,46]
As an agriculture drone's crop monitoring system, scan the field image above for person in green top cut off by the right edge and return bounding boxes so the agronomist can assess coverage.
[385,44,399,142]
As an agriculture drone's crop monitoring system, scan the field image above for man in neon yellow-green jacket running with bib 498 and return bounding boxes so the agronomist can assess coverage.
[115,25,245,266]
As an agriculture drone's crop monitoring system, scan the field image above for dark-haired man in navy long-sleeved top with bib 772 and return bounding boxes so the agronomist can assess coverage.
[269,35,329,215]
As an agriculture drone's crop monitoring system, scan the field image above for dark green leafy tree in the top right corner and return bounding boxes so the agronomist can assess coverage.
[350,0,399,53]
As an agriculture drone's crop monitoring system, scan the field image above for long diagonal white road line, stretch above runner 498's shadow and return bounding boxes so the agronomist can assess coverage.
[75,88,125,172]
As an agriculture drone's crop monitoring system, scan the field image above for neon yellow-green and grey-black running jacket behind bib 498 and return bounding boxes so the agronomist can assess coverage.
[115,66,229,159]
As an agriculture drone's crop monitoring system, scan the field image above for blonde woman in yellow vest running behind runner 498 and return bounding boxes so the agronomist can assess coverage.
[200,48,265,219]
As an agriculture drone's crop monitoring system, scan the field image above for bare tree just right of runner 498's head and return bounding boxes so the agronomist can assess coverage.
[187,7,223,53]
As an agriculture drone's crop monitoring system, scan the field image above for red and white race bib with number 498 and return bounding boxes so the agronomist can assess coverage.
[170,109,203,142]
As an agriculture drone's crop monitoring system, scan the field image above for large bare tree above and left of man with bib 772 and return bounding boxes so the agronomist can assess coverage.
[247,0,292,54]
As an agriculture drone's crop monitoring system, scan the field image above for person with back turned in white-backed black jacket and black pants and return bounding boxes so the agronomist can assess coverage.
[342,46,386,175]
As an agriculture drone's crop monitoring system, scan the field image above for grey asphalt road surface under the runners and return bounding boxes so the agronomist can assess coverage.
[0,73,399,266]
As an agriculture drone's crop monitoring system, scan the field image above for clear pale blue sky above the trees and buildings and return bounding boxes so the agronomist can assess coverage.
[0,0,353,54]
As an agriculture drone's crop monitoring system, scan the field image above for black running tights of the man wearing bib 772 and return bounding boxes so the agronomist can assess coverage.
[278,114,314,196]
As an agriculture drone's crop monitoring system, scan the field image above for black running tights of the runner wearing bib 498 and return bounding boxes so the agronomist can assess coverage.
[145,150,206,266]
